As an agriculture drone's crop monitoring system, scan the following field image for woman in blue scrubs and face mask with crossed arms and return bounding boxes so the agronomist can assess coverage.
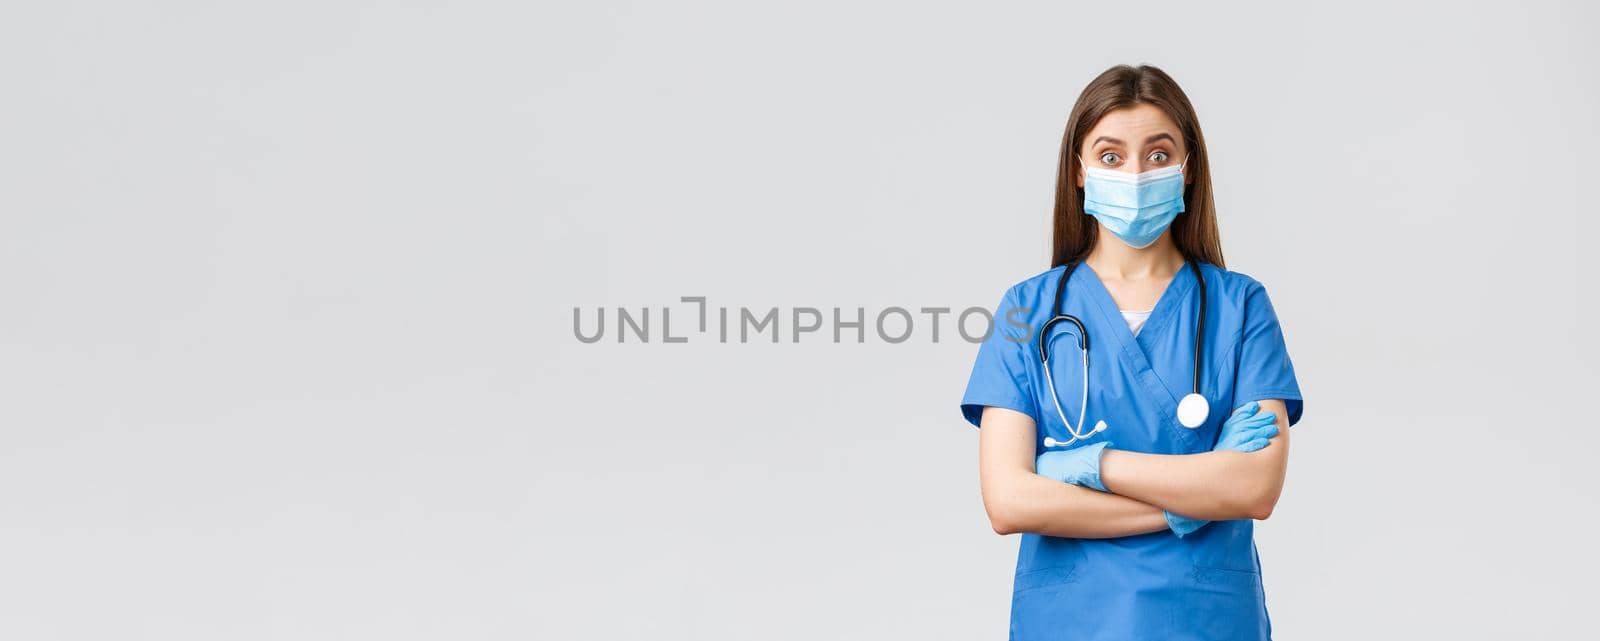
[962,66,1304,641]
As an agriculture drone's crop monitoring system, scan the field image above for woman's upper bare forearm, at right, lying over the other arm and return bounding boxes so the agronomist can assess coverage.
[1101,448,1283,521]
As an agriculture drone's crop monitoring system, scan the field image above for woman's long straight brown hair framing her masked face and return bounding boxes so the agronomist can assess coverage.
[1051,64,1227,269]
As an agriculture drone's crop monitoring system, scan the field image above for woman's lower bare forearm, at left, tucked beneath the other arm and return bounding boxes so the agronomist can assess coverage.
[984,470,1168,539]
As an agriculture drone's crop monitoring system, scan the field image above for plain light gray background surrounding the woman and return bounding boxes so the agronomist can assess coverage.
[0,2,1600,639]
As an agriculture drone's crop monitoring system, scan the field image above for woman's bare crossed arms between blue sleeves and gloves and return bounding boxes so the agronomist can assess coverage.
[978,398,1290,539]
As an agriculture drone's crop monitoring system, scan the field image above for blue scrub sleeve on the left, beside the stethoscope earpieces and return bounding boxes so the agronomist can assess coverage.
[962,288,1038,427]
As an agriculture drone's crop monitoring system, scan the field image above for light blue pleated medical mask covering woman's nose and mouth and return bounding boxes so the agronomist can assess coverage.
[1078,157,1189,249]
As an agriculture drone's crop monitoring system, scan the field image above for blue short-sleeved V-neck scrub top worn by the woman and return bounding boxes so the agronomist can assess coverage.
[962,262,1304,641]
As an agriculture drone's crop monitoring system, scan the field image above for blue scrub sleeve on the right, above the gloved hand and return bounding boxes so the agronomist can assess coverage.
[1234,283,1306,427]
